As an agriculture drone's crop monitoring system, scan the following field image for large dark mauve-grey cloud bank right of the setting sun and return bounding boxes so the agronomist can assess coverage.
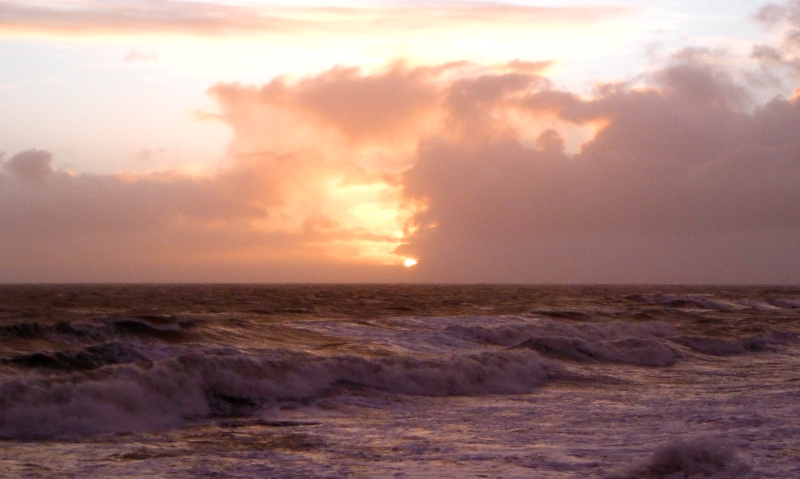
[404,57,800,282]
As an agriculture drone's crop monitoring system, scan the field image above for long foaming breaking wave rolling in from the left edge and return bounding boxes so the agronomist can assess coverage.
[0,350,553,438]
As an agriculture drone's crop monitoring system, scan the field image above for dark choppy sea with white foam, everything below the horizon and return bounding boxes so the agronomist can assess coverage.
[0,285,800,479]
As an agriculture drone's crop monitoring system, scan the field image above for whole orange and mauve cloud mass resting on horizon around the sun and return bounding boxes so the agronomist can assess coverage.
[0,0,800,283]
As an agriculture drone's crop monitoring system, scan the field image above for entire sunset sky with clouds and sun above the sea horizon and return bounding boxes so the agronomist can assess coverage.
[0,0,800,284]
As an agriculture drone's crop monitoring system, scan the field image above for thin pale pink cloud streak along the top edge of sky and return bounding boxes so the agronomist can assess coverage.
[0,0,629,35]
